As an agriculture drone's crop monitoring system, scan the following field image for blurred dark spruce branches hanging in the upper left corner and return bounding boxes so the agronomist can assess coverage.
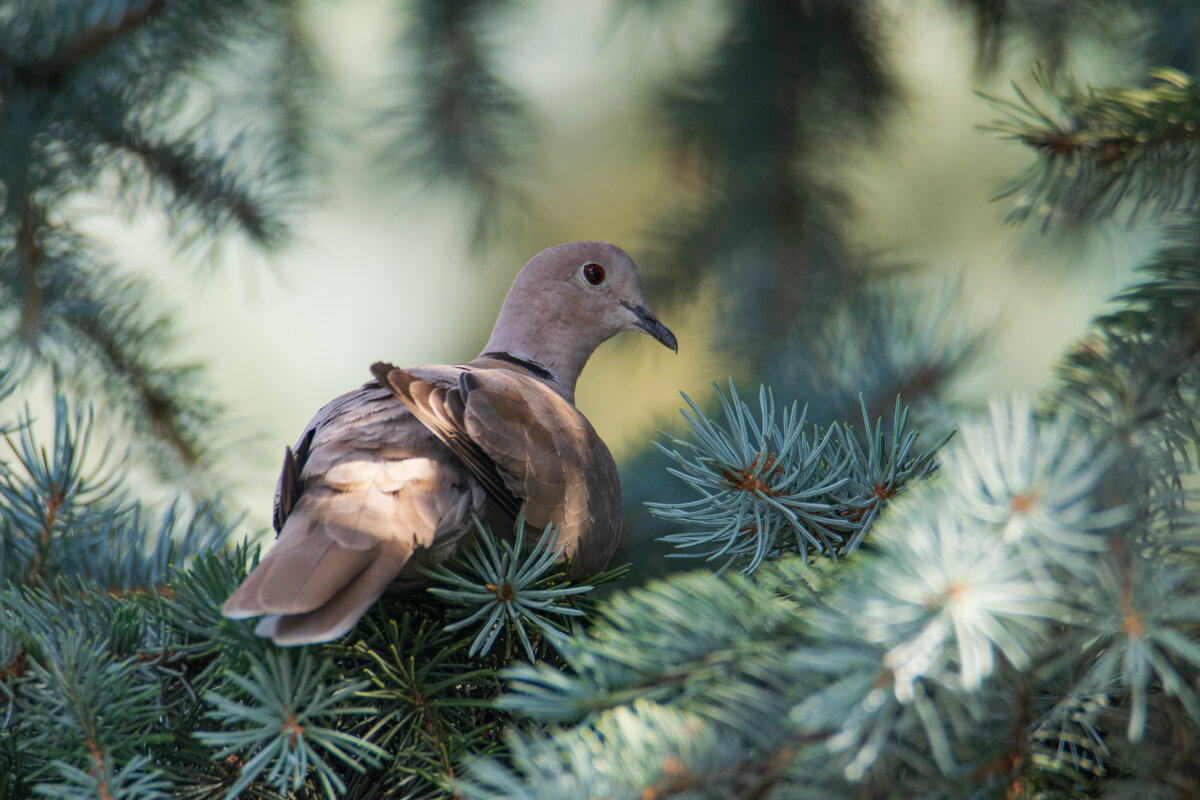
[0,0,300,485]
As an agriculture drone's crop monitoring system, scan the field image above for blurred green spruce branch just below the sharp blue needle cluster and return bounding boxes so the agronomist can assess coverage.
[499,560,811,730]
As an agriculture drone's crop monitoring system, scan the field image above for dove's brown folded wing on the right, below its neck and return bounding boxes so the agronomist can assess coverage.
[373,365,622,575]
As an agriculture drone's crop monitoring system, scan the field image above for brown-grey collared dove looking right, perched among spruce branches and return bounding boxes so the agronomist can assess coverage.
[222,241,679,646]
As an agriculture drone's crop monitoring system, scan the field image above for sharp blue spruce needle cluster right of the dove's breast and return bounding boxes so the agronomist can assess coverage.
[649,380,950,572]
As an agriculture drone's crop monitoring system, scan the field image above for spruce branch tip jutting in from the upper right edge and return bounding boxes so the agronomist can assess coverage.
[984,70,1200,228]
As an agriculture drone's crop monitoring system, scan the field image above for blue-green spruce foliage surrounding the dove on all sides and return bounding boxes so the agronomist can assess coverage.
[0,0,1200,800]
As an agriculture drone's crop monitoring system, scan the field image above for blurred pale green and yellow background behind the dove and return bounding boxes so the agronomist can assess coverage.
[0,0,1180,556]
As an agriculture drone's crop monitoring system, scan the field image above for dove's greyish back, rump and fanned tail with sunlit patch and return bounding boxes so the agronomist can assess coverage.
[224,384,486,644]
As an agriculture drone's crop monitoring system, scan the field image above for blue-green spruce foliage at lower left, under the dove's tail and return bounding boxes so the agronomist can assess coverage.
[0,398,612,800]
